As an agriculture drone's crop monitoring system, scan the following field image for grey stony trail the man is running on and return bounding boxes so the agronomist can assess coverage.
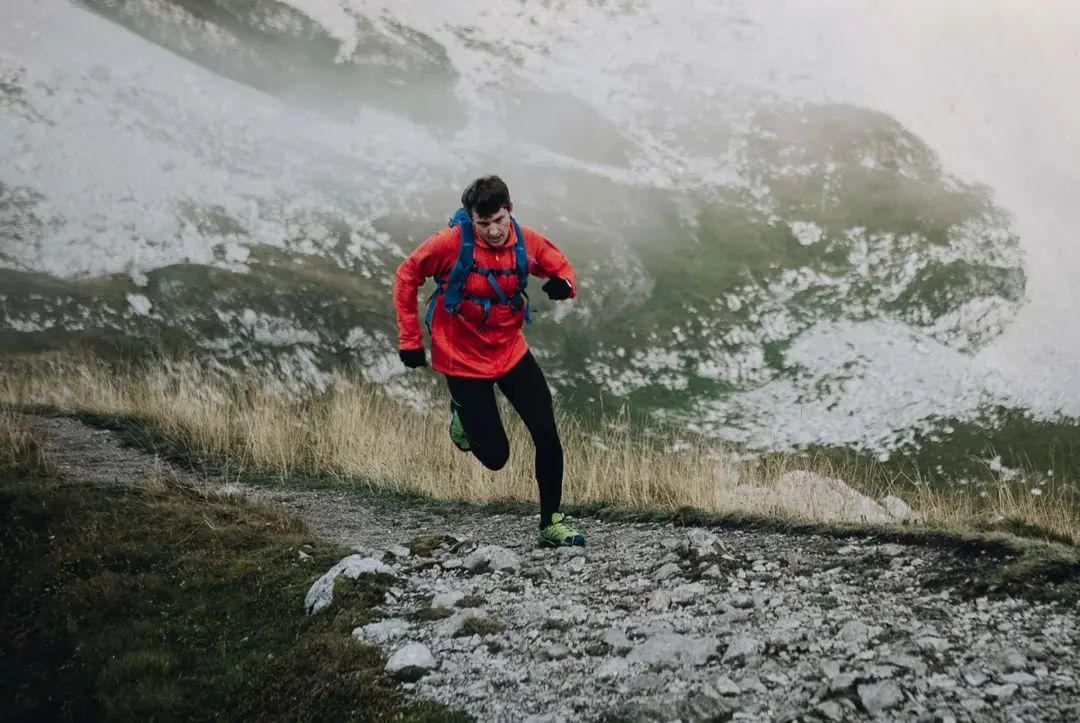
[23,418,1080,721]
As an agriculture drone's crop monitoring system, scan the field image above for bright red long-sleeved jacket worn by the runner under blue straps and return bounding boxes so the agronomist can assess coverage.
[394,220,578,378]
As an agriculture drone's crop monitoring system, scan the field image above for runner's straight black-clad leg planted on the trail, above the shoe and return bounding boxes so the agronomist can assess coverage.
[498,351,563,527]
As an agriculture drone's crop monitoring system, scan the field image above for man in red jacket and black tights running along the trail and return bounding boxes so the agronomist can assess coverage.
[394,176,585,547]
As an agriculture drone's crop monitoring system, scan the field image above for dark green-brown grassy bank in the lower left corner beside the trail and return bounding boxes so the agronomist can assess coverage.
[0,419,461,721]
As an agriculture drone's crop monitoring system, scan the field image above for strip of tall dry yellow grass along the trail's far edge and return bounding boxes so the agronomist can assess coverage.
[0,354,1080,541]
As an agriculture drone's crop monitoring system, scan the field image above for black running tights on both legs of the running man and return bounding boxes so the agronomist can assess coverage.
[446,351,563,527]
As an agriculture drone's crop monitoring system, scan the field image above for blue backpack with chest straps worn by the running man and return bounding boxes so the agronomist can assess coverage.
[424,209,532,331]
